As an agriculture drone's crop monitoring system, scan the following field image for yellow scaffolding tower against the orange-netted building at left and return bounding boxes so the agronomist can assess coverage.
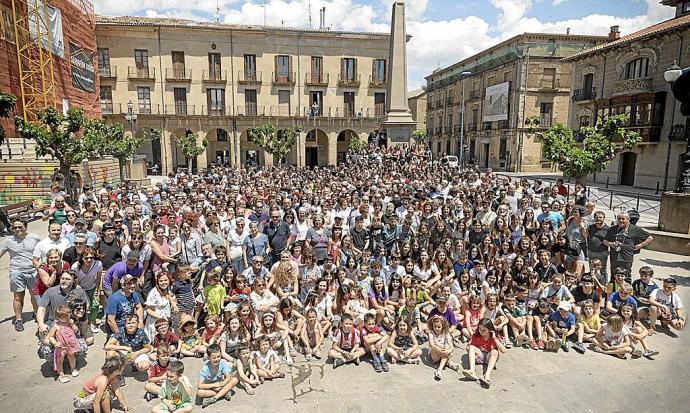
[12,0,57,120]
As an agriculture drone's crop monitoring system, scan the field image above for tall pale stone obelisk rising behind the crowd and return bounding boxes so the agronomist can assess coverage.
[382,1,416,146]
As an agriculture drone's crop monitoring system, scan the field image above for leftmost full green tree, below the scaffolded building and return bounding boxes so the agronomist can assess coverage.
[14,107,97,202]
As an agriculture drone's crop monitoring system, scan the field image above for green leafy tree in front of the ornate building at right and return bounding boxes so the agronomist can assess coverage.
[536,114,640,182]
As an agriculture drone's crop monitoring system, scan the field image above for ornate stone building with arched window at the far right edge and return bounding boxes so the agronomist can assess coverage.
[564,0,690,191]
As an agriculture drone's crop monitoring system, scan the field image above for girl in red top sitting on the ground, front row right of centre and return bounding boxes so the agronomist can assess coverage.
[462,318,506,388]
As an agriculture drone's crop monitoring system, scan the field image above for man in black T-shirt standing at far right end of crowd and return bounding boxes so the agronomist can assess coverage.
[604,212,654,282]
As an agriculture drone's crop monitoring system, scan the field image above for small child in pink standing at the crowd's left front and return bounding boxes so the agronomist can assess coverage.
[46,305,80,383]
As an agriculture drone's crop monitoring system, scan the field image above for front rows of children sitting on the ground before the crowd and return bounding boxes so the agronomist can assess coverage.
[70,267,685,412]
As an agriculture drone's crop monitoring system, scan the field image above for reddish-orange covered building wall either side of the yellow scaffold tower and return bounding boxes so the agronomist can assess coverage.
[0,0,101,136]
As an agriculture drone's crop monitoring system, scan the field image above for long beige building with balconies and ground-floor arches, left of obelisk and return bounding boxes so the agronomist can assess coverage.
[96,17,389,172]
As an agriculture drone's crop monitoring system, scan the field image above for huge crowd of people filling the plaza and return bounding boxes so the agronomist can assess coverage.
[0,143,685,412]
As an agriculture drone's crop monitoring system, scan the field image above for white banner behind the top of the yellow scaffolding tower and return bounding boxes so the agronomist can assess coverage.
[28,0,65,58]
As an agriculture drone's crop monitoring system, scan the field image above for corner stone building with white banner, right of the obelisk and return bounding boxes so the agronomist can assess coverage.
[426,33,606,171]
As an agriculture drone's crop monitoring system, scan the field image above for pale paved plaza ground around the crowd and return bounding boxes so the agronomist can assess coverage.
[0,217,690,413]
